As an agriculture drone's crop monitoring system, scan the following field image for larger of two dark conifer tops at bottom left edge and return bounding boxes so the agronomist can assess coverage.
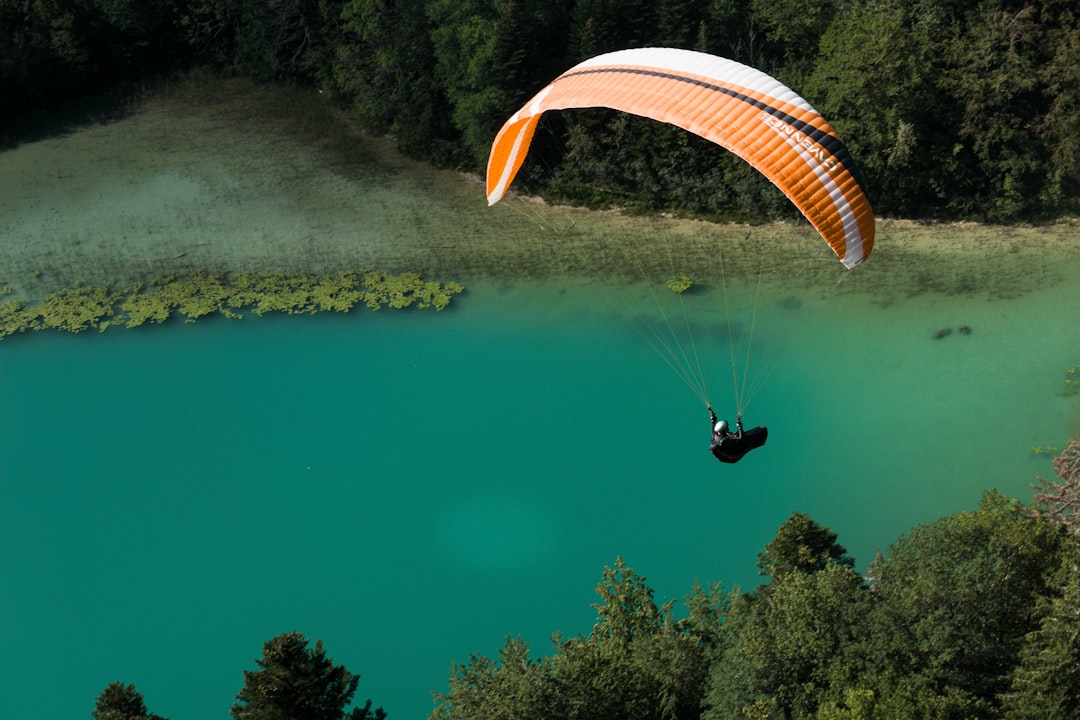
[229,633,386,720]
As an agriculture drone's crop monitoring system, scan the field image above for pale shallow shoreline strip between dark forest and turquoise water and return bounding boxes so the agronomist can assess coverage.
[0,80,1080,305]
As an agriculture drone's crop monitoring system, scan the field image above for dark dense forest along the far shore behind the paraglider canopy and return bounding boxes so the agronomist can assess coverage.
[6,0,1080,223]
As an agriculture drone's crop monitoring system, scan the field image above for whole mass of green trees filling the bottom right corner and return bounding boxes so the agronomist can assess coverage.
[433,492,1080,720]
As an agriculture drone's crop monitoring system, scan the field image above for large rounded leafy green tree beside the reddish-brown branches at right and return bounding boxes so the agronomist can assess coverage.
[869,492,1063,714]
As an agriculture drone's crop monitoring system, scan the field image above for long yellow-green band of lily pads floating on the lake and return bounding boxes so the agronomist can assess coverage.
[0,270,464,340]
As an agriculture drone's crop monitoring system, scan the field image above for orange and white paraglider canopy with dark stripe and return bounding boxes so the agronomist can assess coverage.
[487,47,874,268]
